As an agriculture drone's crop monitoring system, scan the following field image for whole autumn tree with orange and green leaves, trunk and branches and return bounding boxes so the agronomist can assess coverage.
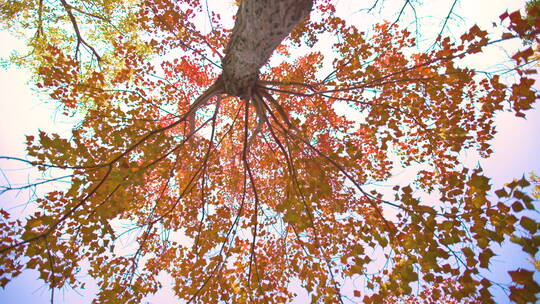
[0,0,540,303]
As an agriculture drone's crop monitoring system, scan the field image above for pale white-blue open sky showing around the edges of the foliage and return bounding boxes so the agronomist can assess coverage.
[0,0,540,304]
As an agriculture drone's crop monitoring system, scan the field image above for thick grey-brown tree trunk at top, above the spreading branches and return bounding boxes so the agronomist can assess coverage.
[220,0,313,97]
